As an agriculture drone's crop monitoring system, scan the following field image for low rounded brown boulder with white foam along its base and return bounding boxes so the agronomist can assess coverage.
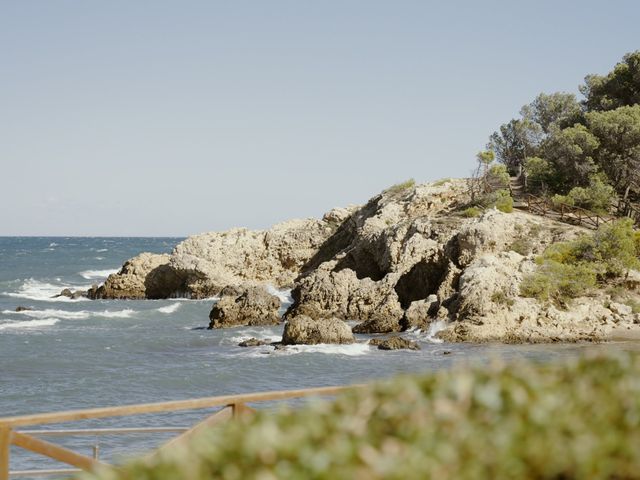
[282,315,355,345]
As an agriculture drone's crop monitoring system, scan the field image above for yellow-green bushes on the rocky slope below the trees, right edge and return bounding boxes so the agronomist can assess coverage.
[520,219,640,303]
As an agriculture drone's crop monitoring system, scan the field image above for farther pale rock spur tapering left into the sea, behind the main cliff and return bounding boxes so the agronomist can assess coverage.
[90,208,353,299]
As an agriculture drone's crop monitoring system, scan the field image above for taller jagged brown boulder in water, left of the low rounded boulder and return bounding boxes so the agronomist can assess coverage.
[209,287,280,329]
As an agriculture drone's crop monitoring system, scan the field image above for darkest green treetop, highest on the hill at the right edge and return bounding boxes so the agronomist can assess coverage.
[580,50,640,110]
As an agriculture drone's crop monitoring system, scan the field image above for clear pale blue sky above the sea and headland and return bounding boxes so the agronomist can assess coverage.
[0,0,640,236]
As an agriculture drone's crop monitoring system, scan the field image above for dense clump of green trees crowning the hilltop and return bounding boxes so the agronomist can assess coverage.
[488,50,640,212]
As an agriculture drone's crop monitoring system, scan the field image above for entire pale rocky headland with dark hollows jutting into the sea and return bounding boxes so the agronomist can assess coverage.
[88,179,640,344]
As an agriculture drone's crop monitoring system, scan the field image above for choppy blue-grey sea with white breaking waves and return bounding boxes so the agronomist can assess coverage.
[0,237,632,472]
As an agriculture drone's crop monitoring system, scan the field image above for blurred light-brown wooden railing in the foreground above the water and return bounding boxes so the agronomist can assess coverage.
[0,385,360,480]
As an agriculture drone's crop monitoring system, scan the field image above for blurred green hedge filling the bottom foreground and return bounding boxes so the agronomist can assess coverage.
[83,354,640,480]
